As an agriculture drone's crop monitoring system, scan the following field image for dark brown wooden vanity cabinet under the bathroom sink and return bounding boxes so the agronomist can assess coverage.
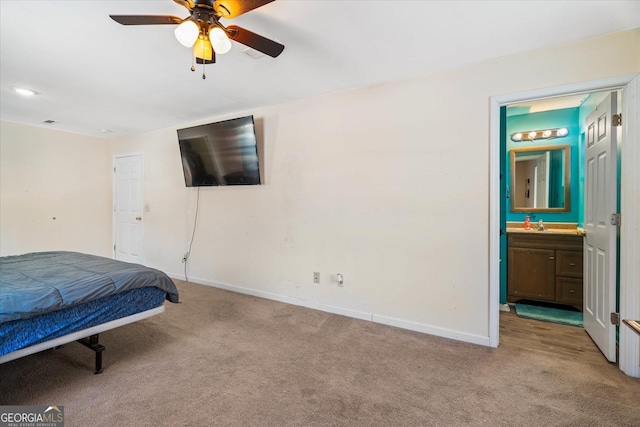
[507,232,583,311]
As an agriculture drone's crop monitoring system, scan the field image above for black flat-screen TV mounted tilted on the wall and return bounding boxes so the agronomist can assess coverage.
[178,116,260,187]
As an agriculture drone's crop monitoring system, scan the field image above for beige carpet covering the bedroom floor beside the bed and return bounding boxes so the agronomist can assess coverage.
[0,281,640,427]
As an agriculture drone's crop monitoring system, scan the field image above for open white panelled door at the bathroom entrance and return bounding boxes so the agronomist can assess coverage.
[584,92,617,362]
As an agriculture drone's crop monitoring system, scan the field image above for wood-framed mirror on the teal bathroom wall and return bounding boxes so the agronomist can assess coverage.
[510,145,571,212]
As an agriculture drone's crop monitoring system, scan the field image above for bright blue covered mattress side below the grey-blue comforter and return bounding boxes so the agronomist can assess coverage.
[0,286,167,357]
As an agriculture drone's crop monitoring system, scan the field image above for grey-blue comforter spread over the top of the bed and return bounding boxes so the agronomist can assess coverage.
[0,252,178,323]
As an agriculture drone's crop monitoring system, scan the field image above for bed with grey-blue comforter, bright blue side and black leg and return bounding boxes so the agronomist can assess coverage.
[0,252,179,373]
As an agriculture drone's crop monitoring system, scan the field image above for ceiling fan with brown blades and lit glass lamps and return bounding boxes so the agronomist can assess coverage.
[109,0,284,79]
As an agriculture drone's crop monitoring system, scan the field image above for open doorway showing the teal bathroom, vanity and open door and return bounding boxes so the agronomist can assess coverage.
[500,90,621,354]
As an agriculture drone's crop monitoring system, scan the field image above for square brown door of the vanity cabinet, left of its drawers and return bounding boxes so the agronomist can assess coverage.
[507,248,556,301]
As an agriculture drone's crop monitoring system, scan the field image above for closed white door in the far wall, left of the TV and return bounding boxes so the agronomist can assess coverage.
[113,154,144,263]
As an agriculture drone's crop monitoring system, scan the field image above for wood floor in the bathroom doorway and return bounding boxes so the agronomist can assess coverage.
[500,308,608,363]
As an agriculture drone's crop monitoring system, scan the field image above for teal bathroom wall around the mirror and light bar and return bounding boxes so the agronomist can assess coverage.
[504,108,582,223]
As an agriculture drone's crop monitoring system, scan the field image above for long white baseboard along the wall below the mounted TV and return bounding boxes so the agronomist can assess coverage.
[167,273,490,346]
